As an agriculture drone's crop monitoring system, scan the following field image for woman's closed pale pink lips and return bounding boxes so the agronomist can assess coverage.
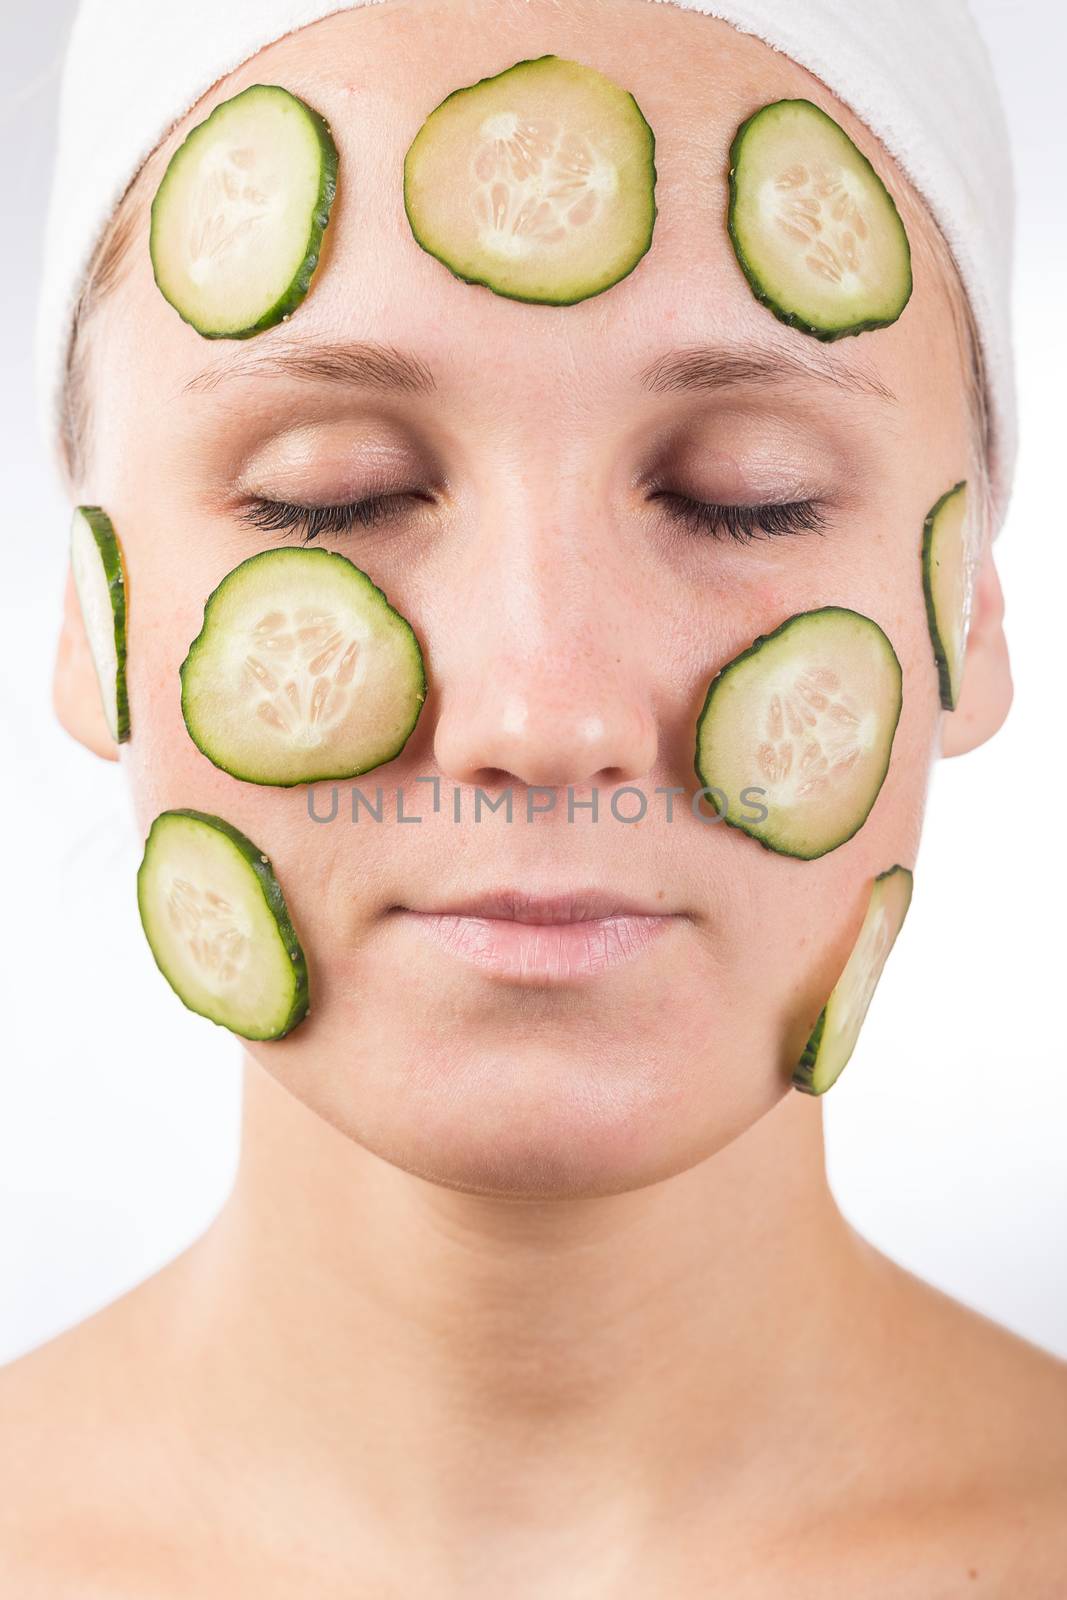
[390,888,688,984]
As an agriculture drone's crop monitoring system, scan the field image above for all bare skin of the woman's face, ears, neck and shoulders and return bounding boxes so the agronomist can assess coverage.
[0,0,1067,1600]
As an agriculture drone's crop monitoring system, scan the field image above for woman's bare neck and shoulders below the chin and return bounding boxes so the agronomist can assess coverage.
[0,1066,1067,1600]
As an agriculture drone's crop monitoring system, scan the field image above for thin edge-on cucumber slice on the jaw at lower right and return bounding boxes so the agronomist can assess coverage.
[793,867,912,1094]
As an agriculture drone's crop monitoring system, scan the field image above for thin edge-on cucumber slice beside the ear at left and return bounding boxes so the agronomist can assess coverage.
[70,506,130,744]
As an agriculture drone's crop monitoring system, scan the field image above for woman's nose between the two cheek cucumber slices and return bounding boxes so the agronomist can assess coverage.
[434,493,657,787]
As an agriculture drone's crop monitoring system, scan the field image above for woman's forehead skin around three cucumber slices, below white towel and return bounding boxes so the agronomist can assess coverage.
[110,0,952,419]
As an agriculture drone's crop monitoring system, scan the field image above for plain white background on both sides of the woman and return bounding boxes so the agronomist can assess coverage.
[0,0,1067,1362]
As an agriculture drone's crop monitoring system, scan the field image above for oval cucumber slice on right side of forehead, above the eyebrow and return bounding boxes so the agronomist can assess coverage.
[726,99,912,341]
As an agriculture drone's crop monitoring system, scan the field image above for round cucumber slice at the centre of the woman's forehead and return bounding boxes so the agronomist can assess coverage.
[403,56,656,306]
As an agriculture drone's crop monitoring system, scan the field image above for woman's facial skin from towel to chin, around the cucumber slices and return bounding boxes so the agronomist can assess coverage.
[80,0,991,1195]
